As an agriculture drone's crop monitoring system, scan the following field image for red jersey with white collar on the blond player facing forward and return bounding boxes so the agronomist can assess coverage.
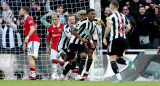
[47,23,64,50]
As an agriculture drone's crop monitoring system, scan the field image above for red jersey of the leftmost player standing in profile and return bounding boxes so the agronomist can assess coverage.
[23,16,41,43]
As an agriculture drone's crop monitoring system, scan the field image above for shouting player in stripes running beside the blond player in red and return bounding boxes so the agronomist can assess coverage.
[56,14,76,80]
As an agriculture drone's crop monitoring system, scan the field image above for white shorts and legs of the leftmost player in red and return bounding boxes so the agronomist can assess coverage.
[26,41,40,80]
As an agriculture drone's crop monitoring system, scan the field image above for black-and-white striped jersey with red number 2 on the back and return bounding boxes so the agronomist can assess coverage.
[107,11,129,41]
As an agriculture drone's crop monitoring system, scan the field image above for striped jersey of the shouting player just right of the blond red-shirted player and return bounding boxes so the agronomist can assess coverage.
[57,24,72,51]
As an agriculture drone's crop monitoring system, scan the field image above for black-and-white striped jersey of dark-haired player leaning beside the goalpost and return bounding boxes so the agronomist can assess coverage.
[70,18,97,45]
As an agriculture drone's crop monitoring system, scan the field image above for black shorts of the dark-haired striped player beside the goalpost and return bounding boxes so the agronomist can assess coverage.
[66,43,87,60]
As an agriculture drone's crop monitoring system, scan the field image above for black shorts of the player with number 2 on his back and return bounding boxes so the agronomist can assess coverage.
[109,37,128,57]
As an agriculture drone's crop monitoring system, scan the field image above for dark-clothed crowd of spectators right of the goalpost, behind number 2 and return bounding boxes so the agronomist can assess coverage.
[101,0,160,49]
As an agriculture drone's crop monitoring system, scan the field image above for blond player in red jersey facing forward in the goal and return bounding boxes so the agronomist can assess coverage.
[47,14,65,78]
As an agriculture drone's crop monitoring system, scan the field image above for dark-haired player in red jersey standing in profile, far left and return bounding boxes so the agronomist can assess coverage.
[19,6,40,80]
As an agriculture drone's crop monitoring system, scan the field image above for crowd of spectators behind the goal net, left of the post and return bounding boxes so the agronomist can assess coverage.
[0,0,89,53]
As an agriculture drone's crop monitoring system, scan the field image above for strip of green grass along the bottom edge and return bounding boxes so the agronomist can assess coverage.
[0,80,160,86]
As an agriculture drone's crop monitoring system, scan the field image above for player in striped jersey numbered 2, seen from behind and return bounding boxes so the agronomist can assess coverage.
[103,0,135,82]
